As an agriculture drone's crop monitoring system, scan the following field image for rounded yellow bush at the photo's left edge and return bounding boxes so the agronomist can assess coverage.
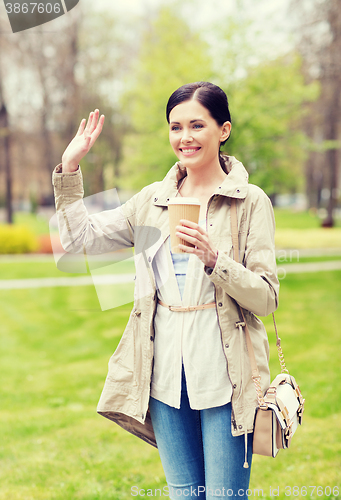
[0,224,39,254]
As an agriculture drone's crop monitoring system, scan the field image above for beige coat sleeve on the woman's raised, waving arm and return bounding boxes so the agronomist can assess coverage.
[52,164,135,255]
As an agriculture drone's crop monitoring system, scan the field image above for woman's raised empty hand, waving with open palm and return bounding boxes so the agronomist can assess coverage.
[62,109,104,172]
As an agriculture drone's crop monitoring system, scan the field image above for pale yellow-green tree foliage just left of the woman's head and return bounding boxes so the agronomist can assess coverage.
[122,7,212,189]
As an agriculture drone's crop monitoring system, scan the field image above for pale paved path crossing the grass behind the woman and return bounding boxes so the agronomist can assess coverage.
[0,260,341,290]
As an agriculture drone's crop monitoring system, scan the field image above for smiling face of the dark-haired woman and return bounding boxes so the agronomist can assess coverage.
[169,99,231,172]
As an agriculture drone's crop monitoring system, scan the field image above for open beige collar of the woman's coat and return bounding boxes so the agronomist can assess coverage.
[153,155,249,206]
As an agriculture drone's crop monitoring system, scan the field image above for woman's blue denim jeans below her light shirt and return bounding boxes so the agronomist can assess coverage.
[149,371,253,500]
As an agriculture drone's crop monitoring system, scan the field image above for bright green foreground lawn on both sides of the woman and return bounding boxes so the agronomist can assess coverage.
[0,262,341,500]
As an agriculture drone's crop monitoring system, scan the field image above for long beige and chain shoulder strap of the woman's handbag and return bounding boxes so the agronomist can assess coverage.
[231,198,289,408]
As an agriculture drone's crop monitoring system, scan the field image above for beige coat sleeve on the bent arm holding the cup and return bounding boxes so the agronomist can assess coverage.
[205,189,279,316]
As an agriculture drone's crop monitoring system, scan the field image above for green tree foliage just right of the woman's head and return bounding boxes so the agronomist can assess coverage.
[225,56,319,195]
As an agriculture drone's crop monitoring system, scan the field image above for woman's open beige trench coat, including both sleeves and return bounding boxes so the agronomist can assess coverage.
[53,157,279,446]
